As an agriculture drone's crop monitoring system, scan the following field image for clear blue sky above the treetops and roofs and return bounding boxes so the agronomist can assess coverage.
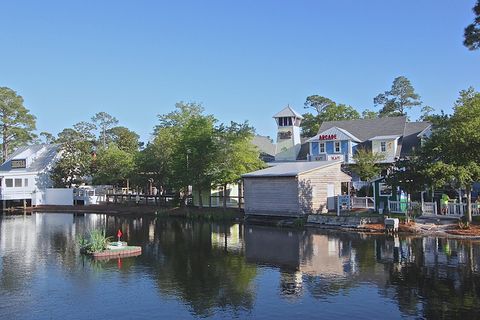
[0,0,480,141]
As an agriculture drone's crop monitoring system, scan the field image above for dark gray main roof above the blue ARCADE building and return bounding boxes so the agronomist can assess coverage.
[318,117,407,141]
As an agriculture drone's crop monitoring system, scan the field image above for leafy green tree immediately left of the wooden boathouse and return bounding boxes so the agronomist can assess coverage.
[212,122,265,208]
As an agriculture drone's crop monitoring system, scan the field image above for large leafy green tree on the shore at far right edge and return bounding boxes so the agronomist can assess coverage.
[423,88,480,221]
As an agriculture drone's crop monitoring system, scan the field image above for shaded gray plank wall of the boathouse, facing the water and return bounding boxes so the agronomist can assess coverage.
[243,177,299,215]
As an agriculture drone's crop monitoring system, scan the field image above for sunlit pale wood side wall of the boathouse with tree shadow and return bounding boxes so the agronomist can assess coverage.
[298,164,351,214]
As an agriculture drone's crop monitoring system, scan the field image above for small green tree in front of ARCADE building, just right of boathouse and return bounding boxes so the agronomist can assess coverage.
[349,148,385,195]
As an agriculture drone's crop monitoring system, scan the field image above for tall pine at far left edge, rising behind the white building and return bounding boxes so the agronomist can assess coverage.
[0,87,36,162]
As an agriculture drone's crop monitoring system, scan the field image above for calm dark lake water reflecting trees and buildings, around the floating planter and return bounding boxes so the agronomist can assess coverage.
[0,213,480,319]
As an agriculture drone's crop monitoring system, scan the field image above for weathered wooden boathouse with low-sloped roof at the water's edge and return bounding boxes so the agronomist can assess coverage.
[242,161,351,217]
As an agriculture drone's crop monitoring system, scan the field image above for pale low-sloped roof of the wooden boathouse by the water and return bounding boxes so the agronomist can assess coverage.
[242,160,342,178]
